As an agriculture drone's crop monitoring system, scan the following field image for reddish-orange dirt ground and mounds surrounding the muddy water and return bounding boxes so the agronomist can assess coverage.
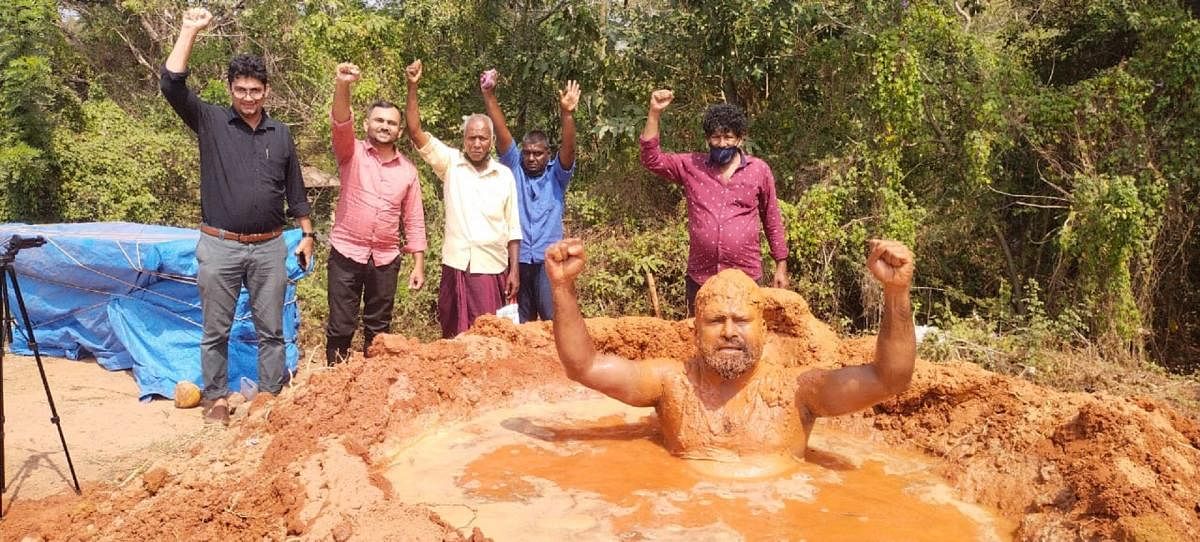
[0,296,1200,541]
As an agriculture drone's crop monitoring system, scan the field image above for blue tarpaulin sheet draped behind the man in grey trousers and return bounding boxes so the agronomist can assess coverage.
[0,222,304,399]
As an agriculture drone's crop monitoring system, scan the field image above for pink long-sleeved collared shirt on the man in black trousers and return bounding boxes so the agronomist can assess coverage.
[329,115,427,267]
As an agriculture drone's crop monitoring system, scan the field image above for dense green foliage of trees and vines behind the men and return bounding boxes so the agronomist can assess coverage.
[0,0,1200,371]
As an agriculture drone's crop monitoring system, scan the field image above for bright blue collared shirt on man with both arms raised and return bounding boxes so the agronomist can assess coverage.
[500,143,575,264]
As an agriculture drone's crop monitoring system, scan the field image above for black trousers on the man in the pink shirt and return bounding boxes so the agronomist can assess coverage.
[325,247,403,363]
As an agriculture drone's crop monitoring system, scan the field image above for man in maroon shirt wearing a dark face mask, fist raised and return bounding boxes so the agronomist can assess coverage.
[641,90,788,315]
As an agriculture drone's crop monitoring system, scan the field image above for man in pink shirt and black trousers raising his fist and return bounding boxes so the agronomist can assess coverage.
[325,62,426,365]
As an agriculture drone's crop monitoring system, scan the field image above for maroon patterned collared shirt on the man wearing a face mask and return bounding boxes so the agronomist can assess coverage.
[640,138,787,284]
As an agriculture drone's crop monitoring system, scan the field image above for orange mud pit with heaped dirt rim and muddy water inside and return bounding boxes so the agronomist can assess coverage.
[0,296,1200,541]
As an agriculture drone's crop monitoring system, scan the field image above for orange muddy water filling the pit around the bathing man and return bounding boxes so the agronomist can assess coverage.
[386,399,1012,541]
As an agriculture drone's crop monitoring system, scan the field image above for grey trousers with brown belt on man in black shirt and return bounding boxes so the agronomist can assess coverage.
[196,234,288,399]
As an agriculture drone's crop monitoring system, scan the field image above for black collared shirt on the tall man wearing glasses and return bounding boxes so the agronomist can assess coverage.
[158,67,308,234]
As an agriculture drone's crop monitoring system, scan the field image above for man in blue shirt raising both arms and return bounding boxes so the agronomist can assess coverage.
[479,70,580,321]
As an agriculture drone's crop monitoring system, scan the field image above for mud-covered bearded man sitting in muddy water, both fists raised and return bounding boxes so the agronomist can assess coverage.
[546,239,917,475]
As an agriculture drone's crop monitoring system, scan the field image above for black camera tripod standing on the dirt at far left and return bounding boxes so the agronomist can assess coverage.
[0,235,79,518]
